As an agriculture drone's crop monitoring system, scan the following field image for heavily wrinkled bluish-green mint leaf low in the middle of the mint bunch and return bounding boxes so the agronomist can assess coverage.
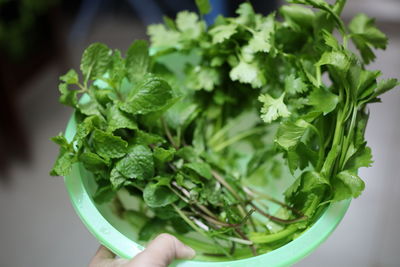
[115,145,154,180]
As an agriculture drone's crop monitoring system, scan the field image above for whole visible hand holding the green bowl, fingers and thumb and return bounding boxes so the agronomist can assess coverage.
[89,234,196,267]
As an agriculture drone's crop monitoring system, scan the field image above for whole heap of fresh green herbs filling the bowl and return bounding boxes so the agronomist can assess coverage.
[51,0,398,258]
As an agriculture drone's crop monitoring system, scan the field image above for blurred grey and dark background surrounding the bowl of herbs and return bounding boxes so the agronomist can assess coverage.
[0,0,400,267]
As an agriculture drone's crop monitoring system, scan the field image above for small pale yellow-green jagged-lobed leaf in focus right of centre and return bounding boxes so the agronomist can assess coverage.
[258,93,290,123]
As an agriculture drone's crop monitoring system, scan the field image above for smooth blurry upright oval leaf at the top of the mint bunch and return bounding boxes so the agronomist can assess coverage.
[125,40,150,82]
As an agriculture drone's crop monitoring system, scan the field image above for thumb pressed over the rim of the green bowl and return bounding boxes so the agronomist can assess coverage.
[129,234,196,267]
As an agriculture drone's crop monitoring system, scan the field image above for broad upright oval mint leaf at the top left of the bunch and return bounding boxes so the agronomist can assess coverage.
[81,43,111,80]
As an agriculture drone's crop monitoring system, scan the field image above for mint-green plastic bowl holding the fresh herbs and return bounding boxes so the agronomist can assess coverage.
[65,116,350,267]
